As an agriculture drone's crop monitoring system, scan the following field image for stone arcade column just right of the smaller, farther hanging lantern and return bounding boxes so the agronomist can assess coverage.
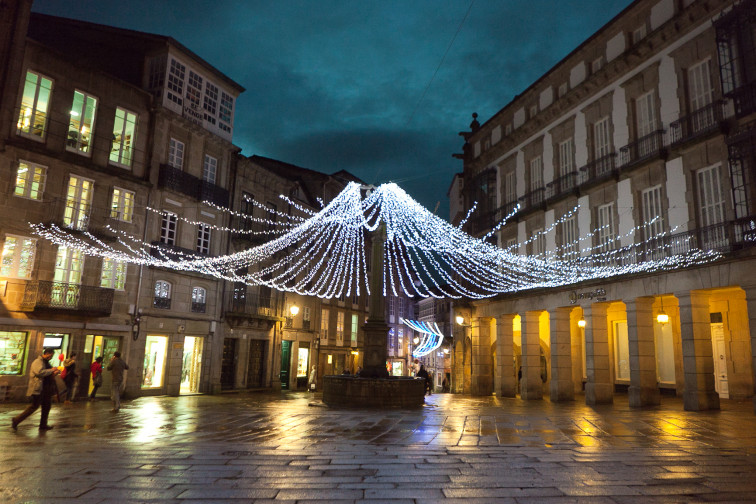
[583,303,614,405]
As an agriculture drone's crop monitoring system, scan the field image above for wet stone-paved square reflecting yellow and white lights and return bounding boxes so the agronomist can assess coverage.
[0,392,756,504]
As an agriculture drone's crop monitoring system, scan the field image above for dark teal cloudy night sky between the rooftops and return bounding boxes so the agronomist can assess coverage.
[33,0,630,218]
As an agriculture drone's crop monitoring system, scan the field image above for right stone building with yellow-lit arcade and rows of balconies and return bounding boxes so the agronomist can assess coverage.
[450,0,756,410]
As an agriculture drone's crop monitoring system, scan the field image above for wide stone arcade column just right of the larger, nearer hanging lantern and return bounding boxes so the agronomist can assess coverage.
[676,291,719,411]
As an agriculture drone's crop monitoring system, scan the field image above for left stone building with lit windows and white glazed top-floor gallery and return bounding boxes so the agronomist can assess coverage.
[0,1,243,399]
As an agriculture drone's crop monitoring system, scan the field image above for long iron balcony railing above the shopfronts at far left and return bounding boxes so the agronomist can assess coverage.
[22,280,113,315]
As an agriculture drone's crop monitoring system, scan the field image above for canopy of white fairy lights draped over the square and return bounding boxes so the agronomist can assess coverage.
[31,183,720,298]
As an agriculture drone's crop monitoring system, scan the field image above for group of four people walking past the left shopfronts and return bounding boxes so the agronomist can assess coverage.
[11,348,129,431]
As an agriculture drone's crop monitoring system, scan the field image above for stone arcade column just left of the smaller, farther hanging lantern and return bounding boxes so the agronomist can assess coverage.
[549,308,575,401]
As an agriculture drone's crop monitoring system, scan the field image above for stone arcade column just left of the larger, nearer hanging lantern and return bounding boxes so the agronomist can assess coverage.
[625,297,661,408]
